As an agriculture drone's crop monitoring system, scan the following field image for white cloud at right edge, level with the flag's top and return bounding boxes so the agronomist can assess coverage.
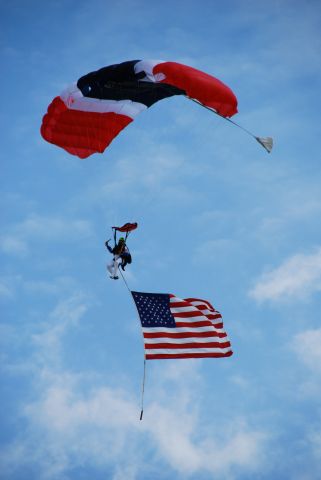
[249,248,321,301]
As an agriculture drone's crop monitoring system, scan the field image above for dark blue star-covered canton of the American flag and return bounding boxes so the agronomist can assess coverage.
[132,292,176,328]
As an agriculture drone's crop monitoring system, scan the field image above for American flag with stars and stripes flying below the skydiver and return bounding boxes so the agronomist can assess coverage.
[131,291,233,360]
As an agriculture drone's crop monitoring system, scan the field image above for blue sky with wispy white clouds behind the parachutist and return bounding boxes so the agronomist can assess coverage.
[0,0,321,480]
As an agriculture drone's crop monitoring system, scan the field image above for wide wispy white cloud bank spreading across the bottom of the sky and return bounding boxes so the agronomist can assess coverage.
[2,372,267,479]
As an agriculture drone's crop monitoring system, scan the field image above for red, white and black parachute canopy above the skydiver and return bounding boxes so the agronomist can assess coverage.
[41,60,237,158]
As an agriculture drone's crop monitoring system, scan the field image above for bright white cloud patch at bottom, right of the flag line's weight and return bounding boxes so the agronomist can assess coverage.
[145,402,267,478]
